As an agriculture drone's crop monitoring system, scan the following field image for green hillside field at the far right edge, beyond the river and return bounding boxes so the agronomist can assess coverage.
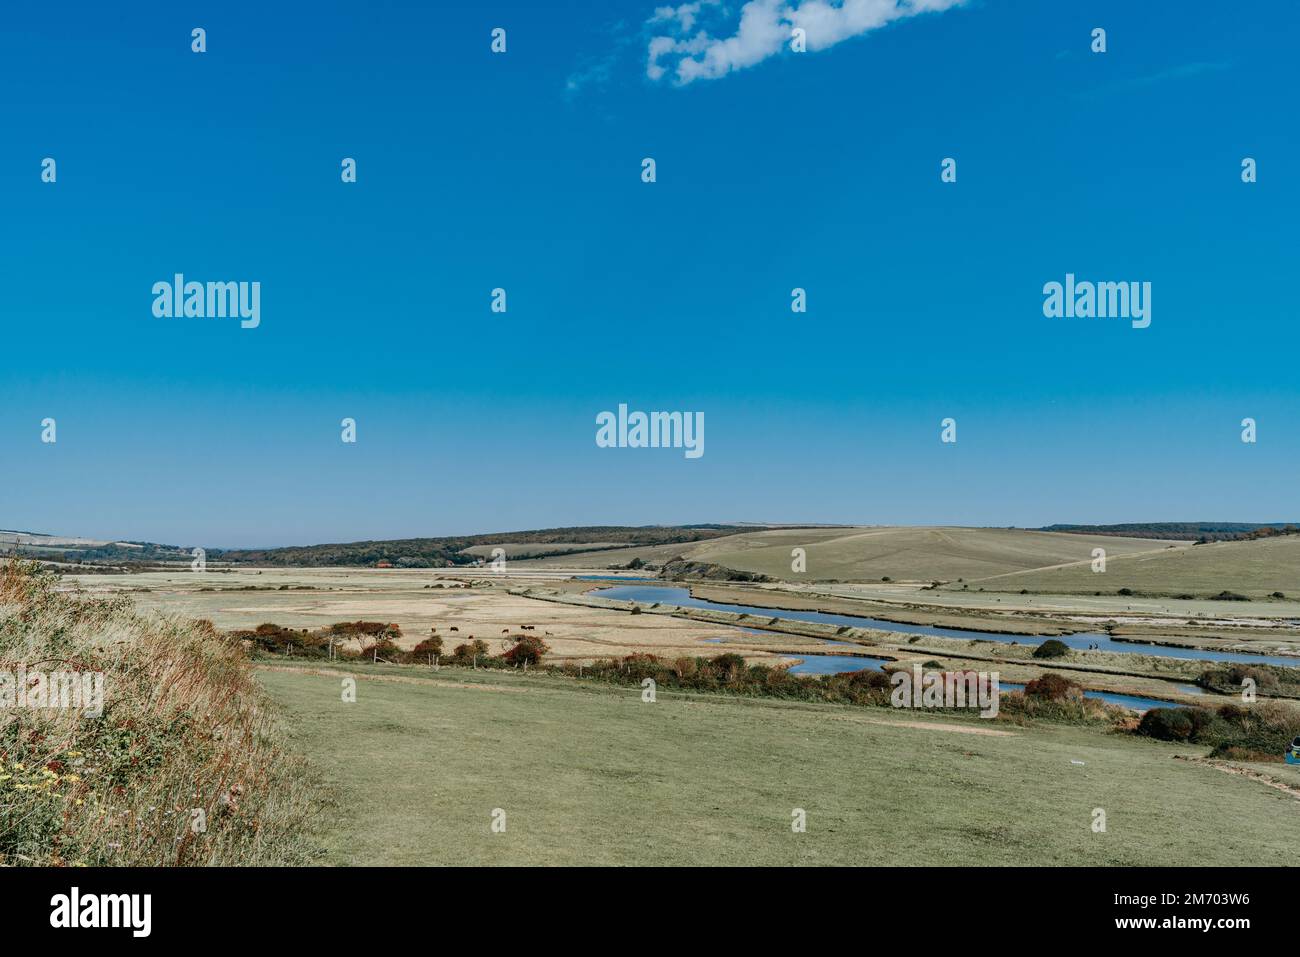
[982,536,1300,598]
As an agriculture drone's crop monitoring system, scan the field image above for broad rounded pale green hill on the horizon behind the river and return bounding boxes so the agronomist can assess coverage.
[520,527,1182,581]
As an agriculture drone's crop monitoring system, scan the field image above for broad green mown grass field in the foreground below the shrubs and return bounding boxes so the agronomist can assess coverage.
[259,666,1300,865]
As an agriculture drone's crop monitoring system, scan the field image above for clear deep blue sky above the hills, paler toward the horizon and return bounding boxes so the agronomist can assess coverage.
[0,0,1300,546]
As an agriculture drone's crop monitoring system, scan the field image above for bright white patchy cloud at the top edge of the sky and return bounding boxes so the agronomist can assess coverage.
[646,0,965,85]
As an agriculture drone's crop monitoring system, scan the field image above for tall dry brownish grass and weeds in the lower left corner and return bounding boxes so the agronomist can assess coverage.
[0,562,321,866]
